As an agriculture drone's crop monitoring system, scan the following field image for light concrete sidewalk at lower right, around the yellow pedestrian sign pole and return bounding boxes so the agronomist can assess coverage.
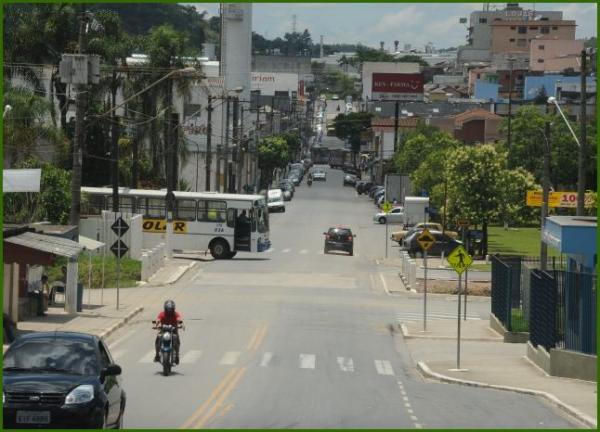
[400,320,597,429]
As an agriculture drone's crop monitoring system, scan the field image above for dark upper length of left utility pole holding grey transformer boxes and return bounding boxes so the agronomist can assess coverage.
[69,4,87,235]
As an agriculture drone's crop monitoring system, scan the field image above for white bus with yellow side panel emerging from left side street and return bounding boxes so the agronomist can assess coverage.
[81,187,271,259]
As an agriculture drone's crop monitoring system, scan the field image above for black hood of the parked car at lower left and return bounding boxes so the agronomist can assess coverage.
[3,372,98,393]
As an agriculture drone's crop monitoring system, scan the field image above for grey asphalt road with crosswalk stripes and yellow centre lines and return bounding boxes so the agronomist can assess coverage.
[109,165,573,428]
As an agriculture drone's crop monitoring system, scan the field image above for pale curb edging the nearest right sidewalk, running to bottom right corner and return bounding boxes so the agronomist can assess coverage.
[417,362,597,429]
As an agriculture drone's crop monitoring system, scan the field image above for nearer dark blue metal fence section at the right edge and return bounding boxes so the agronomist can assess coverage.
[530,270,596,355]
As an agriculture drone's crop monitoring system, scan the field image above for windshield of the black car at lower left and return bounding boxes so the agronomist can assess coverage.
[3,338,100,375]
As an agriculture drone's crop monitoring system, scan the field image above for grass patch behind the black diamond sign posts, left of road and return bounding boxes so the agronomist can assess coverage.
[45,253,142,288]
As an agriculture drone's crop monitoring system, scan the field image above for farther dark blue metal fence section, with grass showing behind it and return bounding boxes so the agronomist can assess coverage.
[492,255,565,332]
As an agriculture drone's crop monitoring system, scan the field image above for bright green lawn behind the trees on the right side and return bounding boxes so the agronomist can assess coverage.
[488,226,560,256]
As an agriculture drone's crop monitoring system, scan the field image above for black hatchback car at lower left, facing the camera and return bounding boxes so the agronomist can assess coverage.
[2,332,126,429]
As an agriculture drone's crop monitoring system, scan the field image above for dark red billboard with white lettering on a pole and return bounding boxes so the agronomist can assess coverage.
[372,72,424,100]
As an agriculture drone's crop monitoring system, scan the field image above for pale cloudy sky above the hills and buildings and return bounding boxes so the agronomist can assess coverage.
[186,3,597,49]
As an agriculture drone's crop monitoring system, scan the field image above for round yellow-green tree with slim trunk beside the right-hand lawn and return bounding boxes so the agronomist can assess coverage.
[447,144,506,255]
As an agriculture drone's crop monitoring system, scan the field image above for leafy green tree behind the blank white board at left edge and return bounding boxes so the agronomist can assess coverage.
[4,158,71,224]
